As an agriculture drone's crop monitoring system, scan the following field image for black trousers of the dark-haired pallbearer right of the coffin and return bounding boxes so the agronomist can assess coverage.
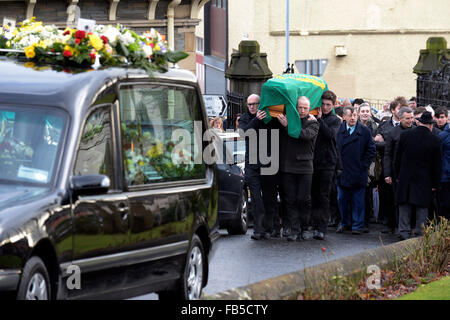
[311,170,334,233]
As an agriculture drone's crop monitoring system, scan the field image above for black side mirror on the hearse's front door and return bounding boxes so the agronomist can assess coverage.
[70,174,111,196]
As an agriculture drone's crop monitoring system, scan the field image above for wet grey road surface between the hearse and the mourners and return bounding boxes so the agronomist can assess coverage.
[133,224,398,300]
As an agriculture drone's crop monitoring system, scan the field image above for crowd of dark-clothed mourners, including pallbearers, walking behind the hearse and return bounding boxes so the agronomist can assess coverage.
[236,91,450,241]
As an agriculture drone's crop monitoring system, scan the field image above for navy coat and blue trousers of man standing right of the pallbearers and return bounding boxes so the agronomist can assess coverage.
[337,121,376,231]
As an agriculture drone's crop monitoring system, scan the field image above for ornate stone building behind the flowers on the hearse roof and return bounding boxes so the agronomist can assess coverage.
[0,0,209,72]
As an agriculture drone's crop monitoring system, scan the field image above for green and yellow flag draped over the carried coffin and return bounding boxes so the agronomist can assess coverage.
[258,73,328,138]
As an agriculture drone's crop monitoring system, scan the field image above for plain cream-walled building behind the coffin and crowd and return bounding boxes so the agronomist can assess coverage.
[227,0,450,104]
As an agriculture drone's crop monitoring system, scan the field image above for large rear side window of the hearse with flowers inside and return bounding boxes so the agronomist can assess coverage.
[120,84,206,185]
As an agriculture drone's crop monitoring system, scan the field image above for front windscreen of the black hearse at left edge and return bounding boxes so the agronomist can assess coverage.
[0,106,67,184]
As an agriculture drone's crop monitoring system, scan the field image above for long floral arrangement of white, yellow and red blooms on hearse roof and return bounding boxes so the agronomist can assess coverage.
[0,17,188,74]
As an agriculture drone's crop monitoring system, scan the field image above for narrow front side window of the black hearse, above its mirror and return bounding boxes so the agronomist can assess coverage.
[74,105,114,188]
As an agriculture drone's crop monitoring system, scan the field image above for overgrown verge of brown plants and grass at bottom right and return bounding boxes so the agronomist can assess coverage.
[292,217,450,300]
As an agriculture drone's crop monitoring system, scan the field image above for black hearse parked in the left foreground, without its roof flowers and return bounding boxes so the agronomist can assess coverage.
[0,57,219,299]
